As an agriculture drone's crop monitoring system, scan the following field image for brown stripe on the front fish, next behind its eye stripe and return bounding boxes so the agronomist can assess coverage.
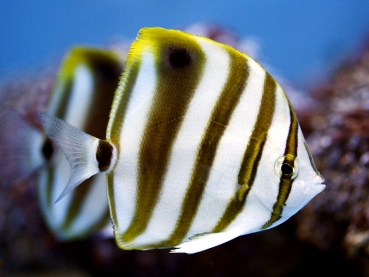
[213,72,276,232]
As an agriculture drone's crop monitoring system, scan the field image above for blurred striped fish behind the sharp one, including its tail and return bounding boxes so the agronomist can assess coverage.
[0,46,124,240]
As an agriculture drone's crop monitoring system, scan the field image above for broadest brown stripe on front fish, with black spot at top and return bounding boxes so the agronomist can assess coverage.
[122,31,205,242]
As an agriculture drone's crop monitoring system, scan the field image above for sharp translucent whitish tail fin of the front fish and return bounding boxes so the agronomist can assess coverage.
[40,113,101,203]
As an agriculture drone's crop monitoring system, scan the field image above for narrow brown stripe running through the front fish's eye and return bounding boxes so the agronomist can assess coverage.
[261,99,298,229]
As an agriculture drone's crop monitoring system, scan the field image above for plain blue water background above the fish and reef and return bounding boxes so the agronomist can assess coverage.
[0,0,369,84]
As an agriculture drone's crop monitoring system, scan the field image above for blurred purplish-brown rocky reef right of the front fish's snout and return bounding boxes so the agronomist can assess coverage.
[296,37,369,276]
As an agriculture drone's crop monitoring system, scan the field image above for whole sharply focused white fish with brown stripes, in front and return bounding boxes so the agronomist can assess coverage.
[41,28,325,253]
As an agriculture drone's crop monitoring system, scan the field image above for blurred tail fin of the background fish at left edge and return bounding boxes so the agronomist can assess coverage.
[0,107,47,186]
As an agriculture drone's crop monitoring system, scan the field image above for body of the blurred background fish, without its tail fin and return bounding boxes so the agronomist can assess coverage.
[38,47,123,240]
